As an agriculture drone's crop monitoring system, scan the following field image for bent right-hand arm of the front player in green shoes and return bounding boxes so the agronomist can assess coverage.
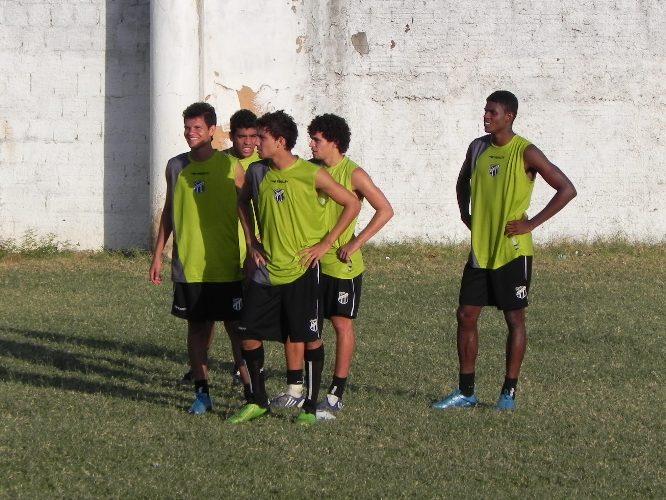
[299,168,361,266]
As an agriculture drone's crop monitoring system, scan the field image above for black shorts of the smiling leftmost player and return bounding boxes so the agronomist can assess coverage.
[171,281,243,321]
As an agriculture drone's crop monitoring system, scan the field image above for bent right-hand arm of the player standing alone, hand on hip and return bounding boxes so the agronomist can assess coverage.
[504,145,577,236]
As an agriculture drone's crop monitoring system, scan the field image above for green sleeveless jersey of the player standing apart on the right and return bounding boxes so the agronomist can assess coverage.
[471,135,534,269]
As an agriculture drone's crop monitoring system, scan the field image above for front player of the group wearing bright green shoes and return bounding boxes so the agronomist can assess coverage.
[229,111,361,424]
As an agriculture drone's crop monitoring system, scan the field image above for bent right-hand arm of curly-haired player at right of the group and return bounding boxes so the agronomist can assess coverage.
[338,168,393,262]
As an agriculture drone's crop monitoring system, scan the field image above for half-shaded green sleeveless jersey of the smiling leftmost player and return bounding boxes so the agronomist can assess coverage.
[167,151,245,283]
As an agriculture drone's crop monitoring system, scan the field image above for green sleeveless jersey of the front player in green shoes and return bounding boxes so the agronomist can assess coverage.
[246,158,327,285]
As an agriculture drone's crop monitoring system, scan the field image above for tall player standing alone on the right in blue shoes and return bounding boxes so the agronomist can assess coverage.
[433,90,576,410]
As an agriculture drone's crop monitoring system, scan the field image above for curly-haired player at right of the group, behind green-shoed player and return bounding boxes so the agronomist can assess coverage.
[271,114,393,419]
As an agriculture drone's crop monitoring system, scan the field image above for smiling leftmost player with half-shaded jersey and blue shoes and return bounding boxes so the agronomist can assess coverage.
[149,102,249,415]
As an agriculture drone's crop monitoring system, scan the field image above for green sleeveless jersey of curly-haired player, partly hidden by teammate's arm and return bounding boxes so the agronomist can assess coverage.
[320,156,365,279]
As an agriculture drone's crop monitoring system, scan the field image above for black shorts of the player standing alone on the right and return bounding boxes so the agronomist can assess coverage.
[459,257,532,311]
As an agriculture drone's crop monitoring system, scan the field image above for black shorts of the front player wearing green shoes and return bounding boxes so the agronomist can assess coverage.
[238,266,323,342]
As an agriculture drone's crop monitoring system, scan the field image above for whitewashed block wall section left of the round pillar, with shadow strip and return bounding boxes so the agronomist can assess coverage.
[0,0,150,249]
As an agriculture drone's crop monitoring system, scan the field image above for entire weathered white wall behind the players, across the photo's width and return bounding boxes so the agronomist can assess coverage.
[0,0,666,248]
